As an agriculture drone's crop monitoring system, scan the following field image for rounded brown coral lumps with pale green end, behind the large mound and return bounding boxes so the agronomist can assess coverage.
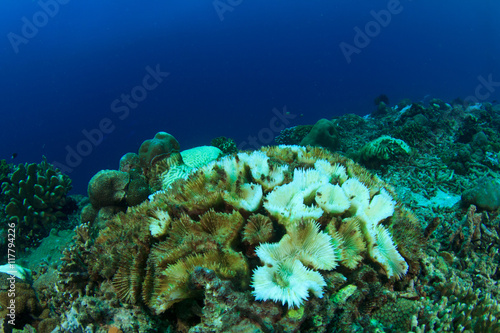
[81,132,222,224]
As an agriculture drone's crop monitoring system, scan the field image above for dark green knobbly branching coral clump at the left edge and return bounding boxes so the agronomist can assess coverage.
[2,157,71,245]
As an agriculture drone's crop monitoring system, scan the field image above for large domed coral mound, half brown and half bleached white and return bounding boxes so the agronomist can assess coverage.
[89,146,420,314]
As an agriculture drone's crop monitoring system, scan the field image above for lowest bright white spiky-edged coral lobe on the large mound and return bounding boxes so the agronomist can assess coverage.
[252,260,326,308]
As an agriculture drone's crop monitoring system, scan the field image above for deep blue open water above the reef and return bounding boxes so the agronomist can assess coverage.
[0,0,500,194]
